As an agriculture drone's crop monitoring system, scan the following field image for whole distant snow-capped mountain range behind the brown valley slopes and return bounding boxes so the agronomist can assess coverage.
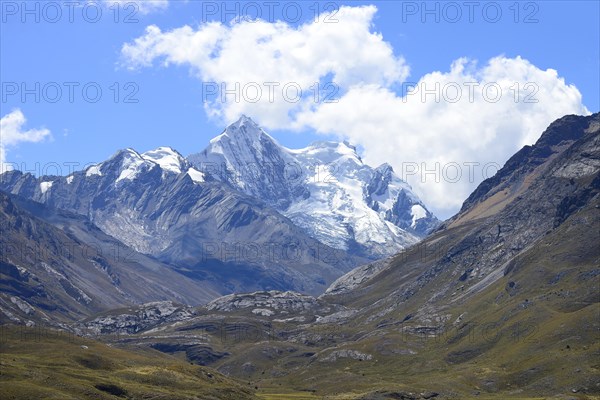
[0,116,438,317]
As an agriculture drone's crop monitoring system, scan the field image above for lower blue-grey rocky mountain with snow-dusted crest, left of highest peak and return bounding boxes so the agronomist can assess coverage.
[0,147,365,294]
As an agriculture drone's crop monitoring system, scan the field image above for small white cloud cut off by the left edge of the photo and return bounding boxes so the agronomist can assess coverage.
[0,109,51,172]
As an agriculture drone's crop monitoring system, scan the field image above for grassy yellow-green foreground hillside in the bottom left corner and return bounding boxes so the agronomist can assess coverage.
[0,326,256,400]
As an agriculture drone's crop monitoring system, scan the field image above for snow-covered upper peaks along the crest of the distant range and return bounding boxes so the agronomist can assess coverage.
[7,116,438,259]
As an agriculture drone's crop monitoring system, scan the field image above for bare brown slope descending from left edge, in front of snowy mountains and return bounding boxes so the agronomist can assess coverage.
[0,192,219,324]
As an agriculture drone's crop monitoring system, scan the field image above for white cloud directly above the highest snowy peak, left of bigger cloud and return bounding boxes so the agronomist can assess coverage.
[122,6,408,128]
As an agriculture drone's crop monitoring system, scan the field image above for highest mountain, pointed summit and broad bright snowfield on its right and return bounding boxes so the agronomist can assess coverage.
[188,116,438,258]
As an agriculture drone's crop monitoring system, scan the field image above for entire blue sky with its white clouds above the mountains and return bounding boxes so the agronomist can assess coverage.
[0,0,600,216]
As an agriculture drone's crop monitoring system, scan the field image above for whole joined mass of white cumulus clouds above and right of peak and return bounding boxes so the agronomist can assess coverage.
[122,6,588,217]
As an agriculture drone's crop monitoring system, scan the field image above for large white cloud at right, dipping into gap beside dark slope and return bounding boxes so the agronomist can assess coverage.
[294,57,589,217]
